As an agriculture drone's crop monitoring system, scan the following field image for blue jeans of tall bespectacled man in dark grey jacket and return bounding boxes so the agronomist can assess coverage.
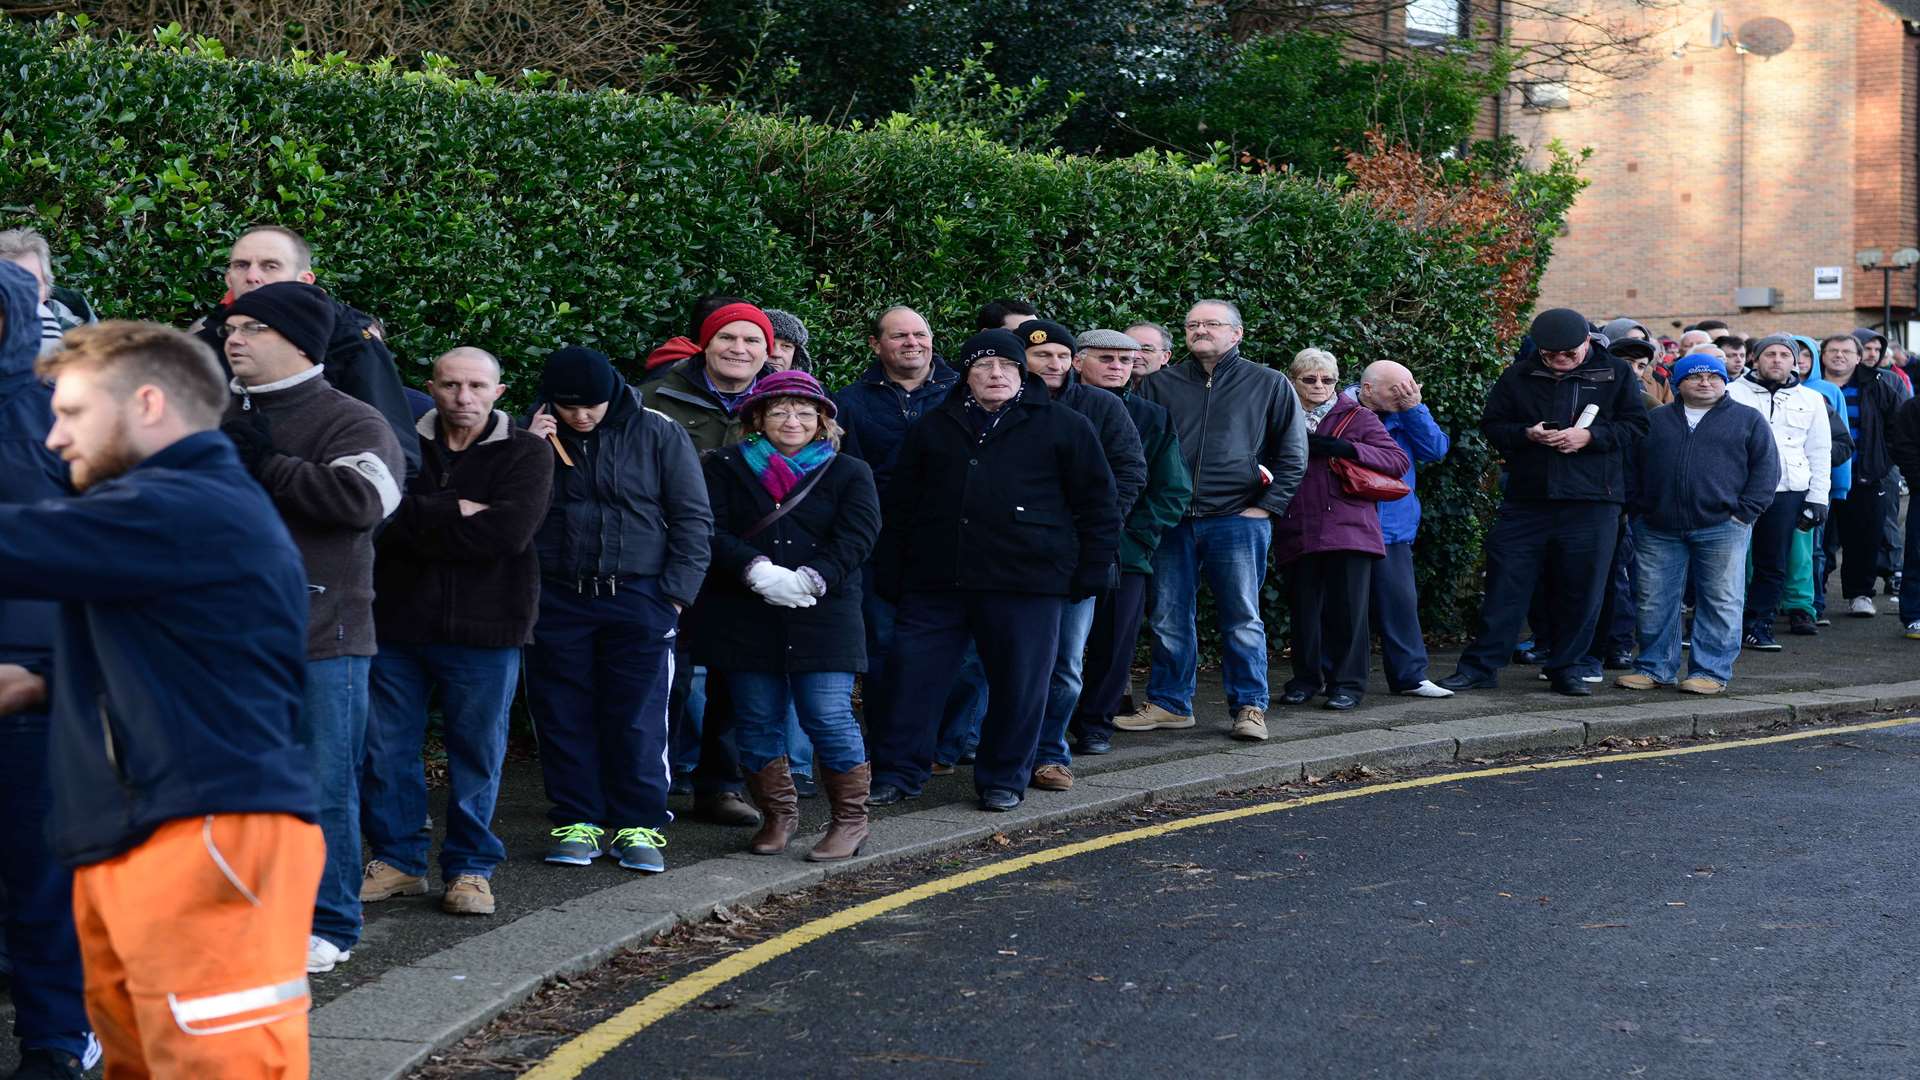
[1146,515,1273,717]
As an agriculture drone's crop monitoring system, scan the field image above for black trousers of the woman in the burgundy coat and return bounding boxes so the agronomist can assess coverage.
[1286,552,1379,698]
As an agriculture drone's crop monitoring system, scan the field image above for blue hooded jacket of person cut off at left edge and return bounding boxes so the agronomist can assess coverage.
[0,261,67,687]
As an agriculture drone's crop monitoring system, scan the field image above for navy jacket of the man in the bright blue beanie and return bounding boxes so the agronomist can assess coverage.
[1634,398,1780,532]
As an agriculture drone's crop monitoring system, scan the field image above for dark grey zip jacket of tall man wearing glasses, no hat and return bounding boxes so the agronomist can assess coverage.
[1139,348,1308,517]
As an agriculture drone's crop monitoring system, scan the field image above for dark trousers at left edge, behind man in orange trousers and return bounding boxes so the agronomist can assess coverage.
[0,713,92,1057]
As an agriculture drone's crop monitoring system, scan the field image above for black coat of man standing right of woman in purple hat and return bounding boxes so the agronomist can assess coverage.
[874,375,1119,598]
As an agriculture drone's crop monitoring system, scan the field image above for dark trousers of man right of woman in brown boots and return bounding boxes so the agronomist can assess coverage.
[868,592,1066,796]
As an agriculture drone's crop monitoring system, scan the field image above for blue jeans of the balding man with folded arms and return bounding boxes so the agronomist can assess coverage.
[361,644,520,880]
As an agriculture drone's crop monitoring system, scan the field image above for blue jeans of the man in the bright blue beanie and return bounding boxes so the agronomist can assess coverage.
[1634,519,1753,684]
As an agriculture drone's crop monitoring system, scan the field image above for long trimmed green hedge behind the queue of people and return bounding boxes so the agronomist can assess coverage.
[0,19,1574,632]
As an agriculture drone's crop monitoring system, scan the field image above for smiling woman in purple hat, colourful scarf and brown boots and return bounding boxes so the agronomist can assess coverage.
[693,371,879,863]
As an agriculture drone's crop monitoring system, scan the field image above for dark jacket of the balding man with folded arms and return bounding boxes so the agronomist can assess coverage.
[372,409,555,650]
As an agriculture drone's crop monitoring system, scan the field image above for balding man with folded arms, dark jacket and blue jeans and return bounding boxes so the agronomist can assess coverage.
[359,348,553,915]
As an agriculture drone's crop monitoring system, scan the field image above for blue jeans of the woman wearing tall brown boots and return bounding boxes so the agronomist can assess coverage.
[726,671,866,773]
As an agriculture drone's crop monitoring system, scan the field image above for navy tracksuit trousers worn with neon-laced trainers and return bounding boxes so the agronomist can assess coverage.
[526,577,678,832]
